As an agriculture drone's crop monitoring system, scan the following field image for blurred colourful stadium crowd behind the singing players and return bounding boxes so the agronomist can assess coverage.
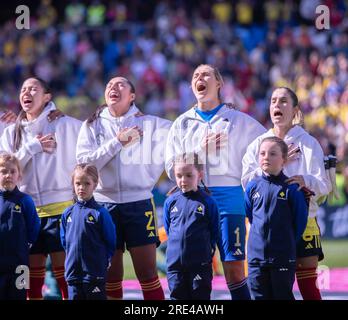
[0,0,348,201]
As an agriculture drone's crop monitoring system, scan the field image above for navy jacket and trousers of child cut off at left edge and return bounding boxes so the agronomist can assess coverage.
[0,187,40,300]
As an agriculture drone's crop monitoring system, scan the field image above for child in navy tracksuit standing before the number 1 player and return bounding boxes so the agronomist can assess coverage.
[163,154,219,300]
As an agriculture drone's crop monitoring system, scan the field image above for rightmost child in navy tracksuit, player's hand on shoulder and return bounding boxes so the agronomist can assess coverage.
[245,137,308,300]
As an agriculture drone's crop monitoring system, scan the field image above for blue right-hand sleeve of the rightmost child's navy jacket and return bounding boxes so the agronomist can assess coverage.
[290,185,308,241]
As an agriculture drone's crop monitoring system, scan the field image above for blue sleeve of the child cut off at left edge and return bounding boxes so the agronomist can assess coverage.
[22,195,40,244]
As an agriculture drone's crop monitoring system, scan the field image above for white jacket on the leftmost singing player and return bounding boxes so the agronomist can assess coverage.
[0,101,81,206]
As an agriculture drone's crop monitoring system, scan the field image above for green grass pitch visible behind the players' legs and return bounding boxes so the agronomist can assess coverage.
[123,240,348,279]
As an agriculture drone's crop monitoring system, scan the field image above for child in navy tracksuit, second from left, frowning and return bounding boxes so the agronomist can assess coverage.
[60,164,116,300]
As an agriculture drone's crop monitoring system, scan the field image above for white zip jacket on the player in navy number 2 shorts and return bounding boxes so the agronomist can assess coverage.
[76,105,171,203]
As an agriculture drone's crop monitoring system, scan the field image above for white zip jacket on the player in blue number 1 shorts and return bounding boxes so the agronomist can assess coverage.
[166,105,266,187]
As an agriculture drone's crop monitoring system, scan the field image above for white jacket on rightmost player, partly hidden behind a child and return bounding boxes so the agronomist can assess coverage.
[242,126,331,217]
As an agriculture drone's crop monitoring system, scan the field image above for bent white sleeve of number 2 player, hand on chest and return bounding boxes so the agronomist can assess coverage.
[76,121,122,170]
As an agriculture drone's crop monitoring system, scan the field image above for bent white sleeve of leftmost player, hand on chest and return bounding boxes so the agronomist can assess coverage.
[0,125,42,168]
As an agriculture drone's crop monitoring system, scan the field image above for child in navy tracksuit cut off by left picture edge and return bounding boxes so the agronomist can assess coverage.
[0,152,40,300]
